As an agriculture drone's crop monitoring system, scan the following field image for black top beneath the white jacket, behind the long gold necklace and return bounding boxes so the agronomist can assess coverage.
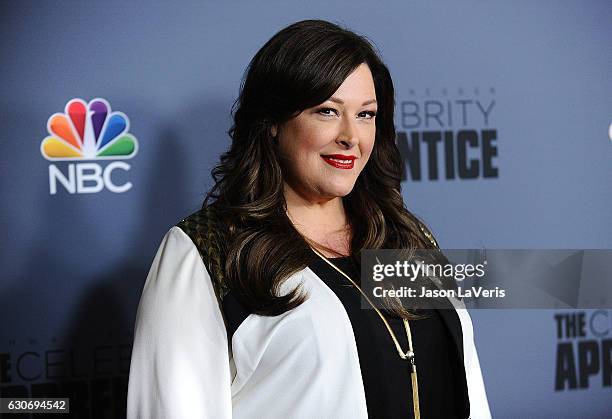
[309,253,469,419]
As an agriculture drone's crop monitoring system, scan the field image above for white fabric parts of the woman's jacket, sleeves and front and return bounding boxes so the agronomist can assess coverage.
[127,227,491,419]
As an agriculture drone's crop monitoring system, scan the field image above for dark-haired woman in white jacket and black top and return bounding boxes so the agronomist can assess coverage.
[128,20,490,418]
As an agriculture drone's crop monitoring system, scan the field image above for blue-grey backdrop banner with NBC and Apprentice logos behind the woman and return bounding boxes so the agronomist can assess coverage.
[0,0,612,418]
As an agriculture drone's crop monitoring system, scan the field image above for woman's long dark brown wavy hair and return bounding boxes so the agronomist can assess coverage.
[203,20,434,317]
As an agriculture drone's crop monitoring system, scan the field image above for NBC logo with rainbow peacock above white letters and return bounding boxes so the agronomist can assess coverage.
[40,98,138,195]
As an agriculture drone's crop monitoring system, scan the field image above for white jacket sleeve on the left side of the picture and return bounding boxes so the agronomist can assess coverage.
[127,227,232,419]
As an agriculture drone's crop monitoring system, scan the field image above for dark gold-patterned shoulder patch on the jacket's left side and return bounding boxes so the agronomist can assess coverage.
[177,207,229,303]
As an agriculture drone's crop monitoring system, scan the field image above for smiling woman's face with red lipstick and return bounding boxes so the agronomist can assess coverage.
[272,63,377,202]
